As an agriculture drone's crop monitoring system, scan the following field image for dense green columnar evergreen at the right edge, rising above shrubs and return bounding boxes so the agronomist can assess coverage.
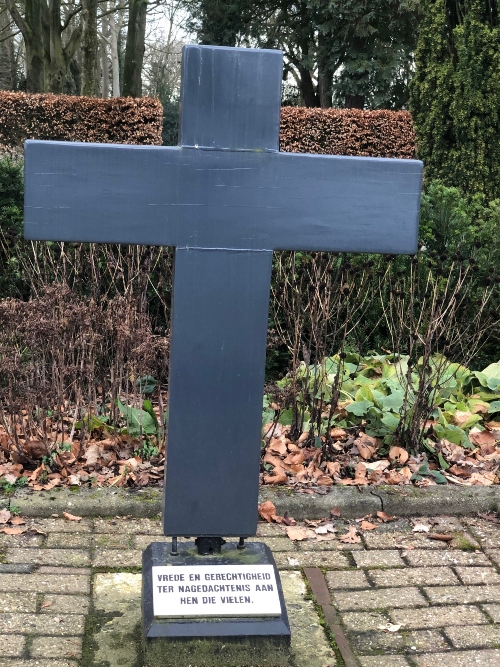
[411,0,500,199]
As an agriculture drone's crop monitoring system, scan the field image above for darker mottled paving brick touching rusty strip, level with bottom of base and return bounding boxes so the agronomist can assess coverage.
[348,628,450,655]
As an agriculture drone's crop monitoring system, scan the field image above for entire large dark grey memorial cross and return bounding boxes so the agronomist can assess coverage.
[25,46,422,536]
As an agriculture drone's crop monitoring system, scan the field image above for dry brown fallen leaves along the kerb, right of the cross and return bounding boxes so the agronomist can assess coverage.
[261,422,500,493]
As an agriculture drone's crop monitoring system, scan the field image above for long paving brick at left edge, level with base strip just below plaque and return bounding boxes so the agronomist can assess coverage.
[0,614,85,636]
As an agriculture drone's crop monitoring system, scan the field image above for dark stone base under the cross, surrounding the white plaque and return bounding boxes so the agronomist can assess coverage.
[142,542,291,667]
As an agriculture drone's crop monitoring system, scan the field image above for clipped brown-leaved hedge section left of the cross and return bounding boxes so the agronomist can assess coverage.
[0,91,163,149]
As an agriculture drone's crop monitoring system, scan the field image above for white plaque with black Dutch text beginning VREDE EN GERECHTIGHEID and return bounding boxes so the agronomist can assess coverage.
[152,565,281,617]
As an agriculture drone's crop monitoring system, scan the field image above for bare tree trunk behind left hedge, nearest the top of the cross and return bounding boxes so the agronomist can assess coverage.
[123,0,148,97]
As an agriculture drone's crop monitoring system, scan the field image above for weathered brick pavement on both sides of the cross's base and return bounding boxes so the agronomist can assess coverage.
[0,518,500,667]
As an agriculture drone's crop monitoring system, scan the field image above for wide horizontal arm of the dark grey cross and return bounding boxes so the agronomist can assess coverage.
[25,141,422,253]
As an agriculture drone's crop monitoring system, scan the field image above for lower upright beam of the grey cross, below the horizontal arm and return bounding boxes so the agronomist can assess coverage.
[163,248,272,536]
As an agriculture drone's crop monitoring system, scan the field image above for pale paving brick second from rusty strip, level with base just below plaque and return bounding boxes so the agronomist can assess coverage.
[390,605,488,628]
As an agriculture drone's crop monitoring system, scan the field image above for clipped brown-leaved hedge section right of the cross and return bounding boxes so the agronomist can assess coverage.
[280,107,416,158]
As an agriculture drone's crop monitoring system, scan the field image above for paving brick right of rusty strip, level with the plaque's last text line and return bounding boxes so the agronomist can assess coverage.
[332,587,428,611]
